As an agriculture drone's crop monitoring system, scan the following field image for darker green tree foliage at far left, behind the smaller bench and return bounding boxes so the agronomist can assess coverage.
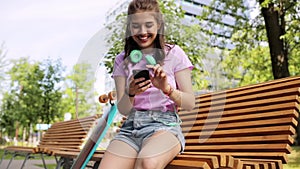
[0,58,63,136]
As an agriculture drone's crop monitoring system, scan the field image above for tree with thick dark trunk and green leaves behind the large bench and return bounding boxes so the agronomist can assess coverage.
[202,0,300,85]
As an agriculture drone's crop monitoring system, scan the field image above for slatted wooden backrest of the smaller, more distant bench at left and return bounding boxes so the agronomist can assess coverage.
[38,115,100,150]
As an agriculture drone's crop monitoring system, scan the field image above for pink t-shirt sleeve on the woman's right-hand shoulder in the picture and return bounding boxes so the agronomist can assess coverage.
[170,45,194,72]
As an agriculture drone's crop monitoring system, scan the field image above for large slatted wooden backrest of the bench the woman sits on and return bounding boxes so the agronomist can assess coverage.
[179,77,300,163]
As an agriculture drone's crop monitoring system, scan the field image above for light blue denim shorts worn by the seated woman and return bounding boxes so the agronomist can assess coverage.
[113,111,185,152]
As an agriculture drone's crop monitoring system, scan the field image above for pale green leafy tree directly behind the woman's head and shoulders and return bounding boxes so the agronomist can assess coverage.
[105,0,210,90]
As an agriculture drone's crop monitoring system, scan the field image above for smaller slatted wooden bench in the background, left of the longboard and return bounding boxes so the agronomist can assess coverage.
[0,115,100,168]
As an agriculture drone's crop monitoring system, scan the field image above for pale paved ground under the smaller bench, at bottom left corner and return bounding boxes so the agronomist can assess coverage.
[0,159,55,169]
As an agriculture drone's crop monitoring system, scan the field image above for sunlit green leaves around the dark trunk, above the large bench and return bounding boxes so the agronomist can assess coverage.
[200,0,300,86]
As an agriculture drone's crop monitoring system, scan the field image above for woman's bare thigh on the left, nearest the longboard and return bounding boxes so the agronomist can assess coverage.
[99,140,137,169]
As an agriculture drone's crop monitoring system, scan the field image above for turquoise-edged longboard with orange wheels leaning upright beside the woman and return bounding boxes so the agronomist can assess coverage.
[71,92,117,169]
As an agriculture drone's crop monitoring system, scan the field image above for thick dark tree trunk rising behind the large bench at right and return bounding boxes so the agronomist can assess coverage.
[260,0,290,79]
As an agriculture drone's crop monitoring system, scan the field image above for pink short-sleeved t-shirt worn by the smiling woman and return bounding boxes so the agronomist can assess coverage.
[113,45,194,112]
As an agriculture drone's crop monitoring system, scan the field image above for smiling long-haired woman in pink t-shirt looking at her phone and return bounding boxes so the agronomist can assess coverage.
[99,0,195,169]
